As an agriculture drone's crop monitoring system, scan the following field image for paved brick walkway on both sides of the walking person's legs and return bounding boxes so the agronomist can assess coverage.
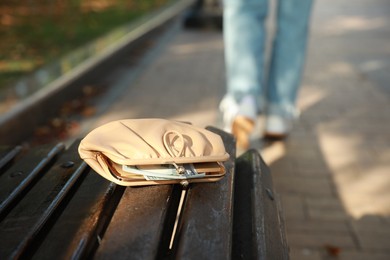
[79,0,390,260]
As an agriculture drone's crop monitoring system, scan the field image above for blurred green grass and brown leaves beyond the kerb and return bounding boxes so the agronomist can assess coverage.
[0,0,173,87]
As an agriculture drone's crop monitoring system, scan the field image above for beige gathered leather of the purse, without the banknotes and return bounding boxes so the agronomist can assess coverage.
[79,119,229,185]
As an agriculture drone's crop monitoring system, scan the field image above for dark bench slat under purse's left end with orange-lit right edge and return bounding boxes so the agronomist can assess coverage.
[32,168,123,259]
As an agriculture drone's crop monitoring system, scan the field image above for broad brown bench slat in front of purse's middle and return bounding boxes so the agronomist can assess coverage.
[95,185,181,259]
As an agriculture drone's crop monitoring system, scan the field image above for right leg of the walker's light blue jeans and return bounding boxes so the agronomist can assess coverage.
[267,0,312,117]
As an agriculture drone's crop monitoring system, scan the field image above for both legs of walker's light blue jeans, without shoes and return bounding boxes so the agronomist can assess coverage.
[224,0,312,117]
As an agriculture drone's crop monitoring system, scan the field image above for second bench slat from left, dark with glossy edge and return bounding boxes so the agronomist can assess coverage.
[0,143,65,218]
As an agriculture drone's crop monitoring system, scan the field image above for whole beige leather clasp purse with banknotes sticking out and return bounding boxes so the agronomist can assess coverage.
[79,119,229,186]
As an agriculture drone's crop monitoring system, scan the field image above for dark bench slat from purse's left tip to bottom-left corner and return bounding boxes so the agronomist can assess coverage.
[0,143,81,259]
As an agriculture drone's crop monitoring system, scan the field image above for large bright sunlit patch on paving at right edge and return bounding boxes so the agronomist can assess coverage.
[319,127,390,218]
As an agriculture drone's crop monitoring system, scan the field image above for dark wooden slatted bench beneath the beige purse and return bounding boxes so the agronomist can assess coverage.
[0,127,288,260]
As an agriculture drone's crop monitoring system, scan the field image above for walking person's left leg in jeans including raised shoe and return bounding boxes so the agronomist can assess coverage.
[220,0,268,146]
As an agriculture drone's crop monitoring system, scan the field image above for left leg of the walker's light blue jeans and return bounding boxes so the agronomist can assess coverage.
[224,0,268,103]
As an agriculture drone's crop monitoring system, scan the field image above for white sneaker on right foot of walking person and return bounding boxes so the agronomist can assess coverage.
[264,115,292,139]
